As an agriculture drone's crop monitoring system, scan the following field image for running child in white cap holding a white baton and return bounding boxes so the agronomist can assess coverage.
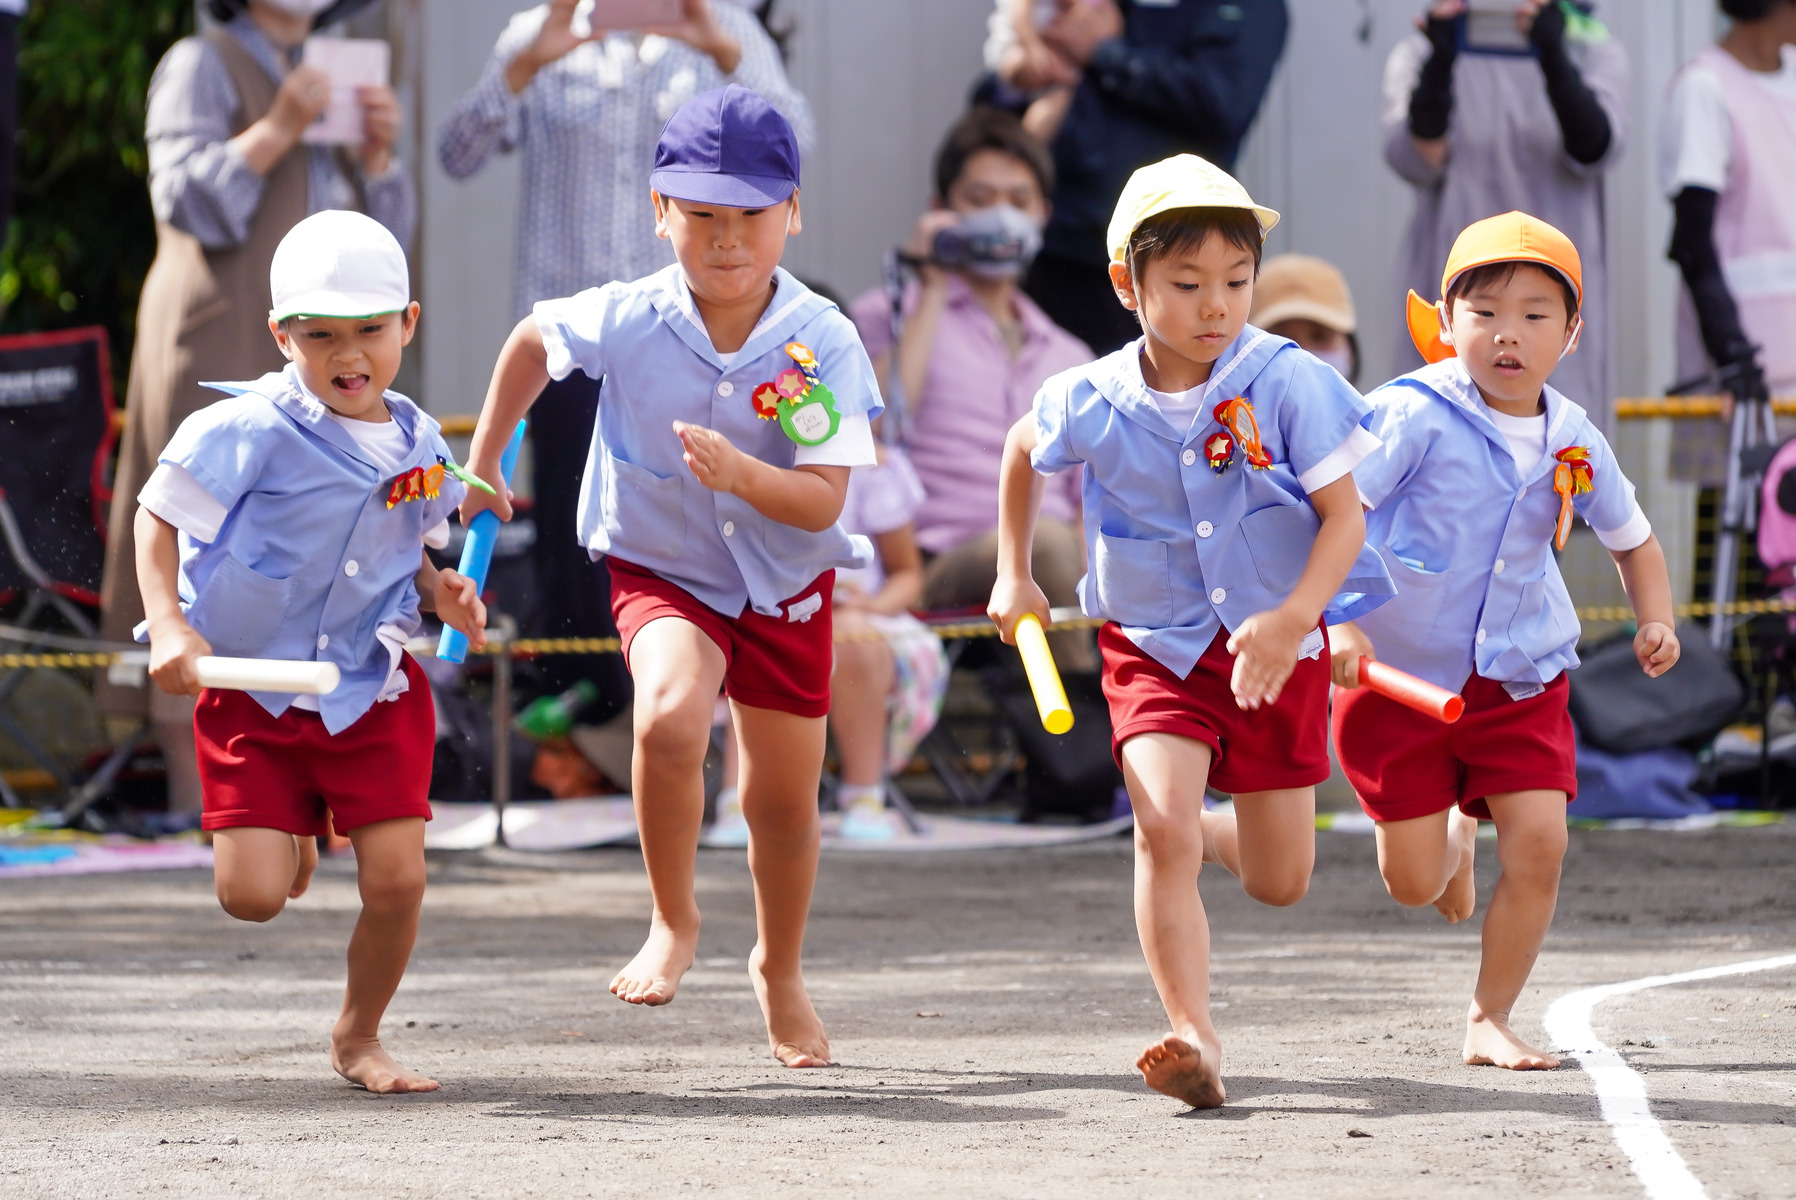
[136,212,487,1092]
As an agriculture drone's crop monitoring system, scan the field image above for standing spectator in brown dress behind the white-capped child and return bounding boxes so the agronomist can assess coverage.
[99,0,417,808]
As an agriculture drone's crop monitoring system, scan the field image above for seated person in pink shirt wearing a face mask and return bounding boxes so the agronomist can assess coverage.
[850,108,1096,670]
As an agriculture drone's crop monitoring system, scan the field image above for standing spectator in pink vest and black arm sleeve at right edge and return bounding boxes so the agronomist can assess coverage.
[1660,0,1796,425]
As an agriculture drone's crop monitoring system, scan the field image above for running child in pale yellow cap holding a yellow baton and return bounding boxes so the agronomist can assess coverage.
[990,154,1390,1108]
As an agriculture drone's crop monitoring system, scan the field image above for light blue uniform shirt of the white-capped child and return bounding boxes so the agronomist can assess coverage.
[136,366,467,733]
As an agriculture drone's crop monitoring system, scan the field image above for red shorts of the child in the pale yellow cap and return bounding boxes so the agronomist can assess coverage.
[1097,622,1329,794]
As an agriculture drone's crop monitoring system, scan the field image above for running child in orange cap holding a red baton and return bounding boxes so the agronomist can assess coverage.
[1329,212,1677,1071]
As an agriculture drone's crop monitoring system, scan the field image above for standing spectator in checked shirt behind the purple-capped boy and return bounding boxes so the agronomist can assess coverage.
[436,0,815,708]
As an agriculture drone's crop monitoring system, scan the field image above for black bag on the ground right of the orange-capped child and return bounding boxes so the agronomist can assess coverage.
[1570,625,1746,754]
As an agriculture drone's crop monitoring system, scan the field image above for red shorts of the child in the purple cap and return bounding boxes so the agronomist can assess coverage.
[607,559,835,717]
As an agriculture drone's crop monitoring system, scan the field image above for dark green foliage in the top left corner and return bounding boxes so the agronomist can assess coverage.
[0,0,194,391]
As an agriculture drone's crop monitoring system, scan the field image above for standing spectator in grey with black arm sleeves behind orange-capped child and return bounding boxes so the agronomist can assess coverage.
[1383,0,1629,429]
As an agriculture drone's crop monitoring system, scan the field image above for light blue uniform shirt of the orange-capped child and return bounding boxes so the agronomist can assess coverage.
[1354,357,1652,699]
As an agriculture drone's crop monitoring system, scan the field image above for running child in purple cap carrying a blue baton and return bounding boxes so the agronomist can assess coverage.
[462,84,882,1067]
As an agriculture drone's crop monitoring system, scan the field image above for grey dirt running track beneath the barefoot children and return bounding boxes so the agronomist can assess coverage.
[0,826,1796,1200]
